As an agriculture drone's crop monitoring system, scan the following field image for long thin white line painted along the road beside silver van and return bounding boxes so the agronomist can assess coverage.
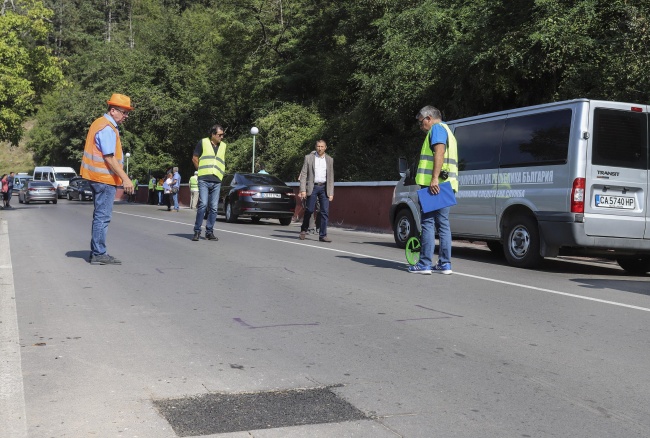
[116,212,650,312]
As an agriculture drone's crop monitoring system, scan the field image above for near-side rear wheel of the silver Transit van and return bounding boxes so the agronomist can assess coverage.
[503,216,543,268]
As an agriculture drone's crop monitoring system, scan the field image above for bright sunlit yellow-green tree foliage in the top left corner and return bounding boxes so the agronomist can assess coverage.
[0,0,63,145]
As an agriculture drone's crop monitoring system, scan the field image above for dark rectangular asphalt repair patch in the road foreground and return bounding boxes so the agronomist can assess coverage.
[153,386,369,437]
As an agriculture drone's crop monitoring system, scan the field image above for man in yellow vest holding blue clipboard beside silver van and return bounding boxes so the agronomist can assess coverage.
[409,106,458,275]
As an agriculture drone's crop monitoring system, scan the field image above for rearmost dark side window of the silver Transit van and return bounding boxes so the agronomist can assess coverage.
[501,109,571,167]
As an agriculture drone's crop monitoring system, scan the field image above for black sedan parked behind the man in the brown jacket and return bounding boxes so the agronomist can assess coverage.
[218,173,296,225]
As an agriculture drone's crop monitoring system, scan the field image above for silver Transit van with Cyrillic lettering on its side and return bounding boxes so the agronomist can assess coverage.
[390,99,650,274]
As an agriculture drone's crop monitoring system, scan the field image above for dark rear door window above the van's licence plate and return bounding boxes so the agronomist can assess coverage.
[591,108,648,170]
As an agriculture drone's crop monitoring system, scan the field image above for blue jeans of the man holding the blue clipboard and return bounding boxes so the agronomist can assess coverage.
[420,207,451,266]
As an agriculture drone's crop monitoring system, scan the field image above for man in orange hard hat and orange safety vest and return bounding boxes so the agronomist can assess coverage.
[81,94,133,265]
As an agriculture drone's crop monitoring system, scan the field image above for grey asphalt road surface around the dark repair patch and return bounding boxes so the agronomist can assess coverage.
[0,200,650,438]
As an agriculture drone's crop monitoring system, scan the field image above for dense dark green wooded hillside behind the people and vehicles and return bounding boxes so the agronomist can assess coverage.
[19,0,650,181]
